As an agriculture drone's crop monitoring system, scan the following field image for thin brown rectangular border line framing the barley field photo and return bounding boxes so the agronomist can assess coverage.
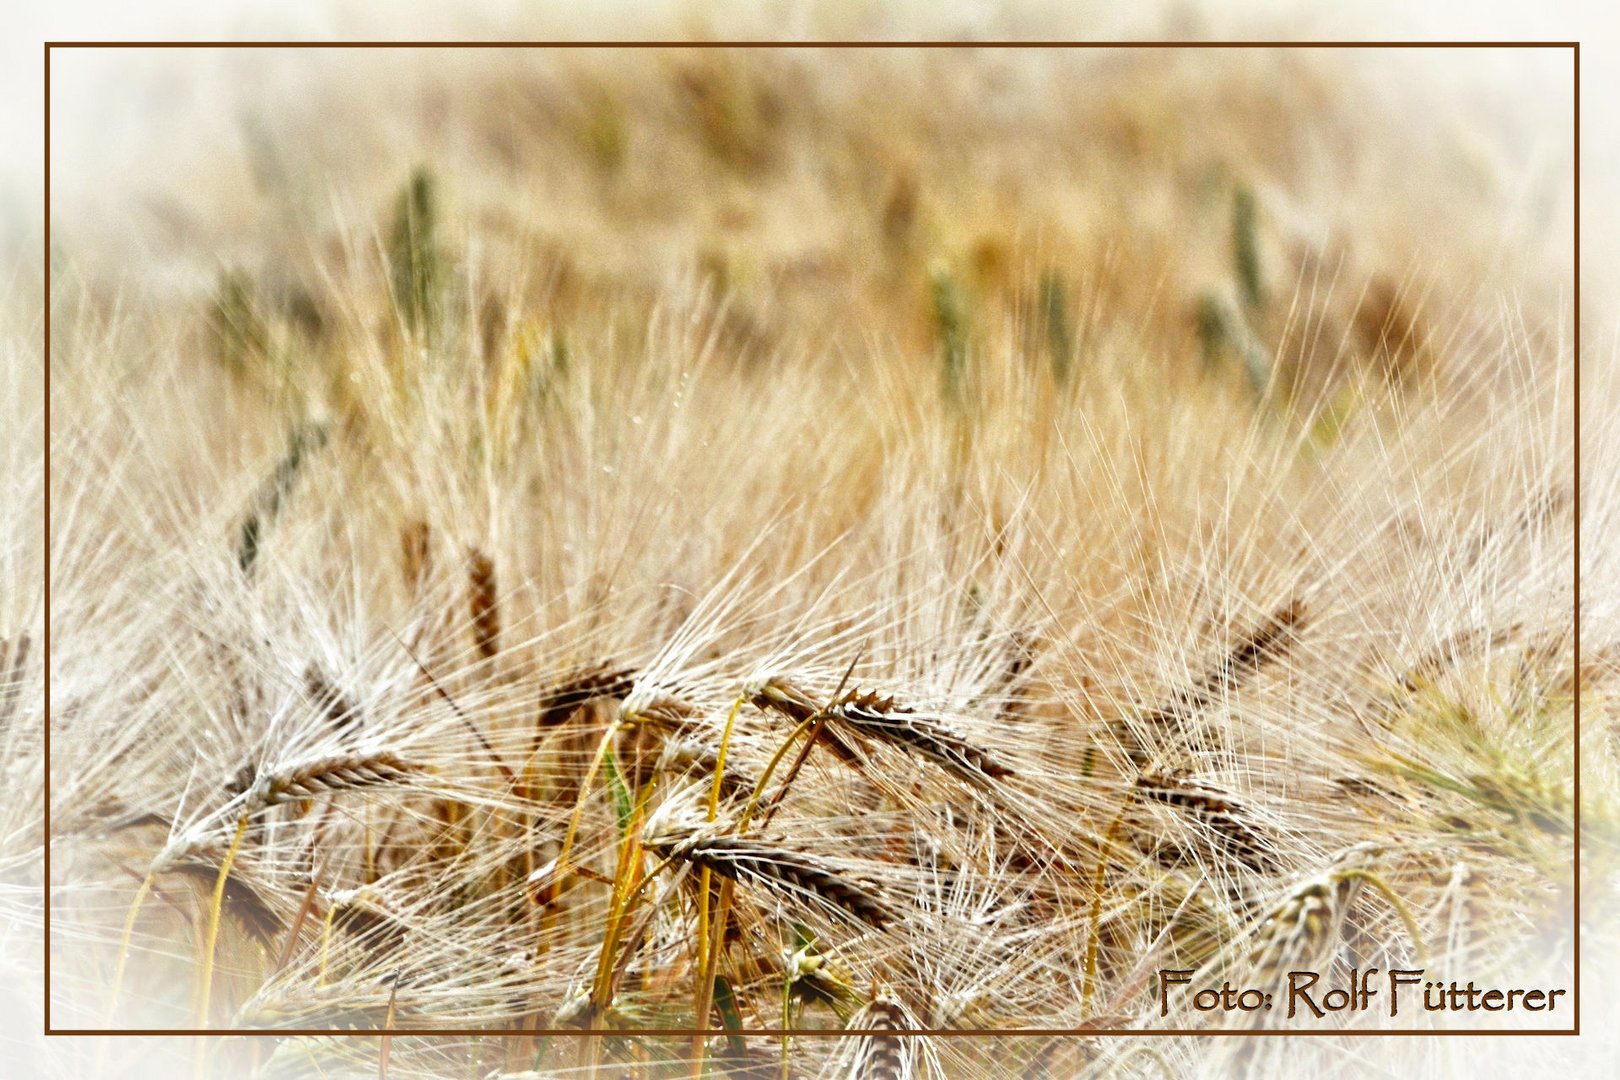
[42,40,1581,1038]
